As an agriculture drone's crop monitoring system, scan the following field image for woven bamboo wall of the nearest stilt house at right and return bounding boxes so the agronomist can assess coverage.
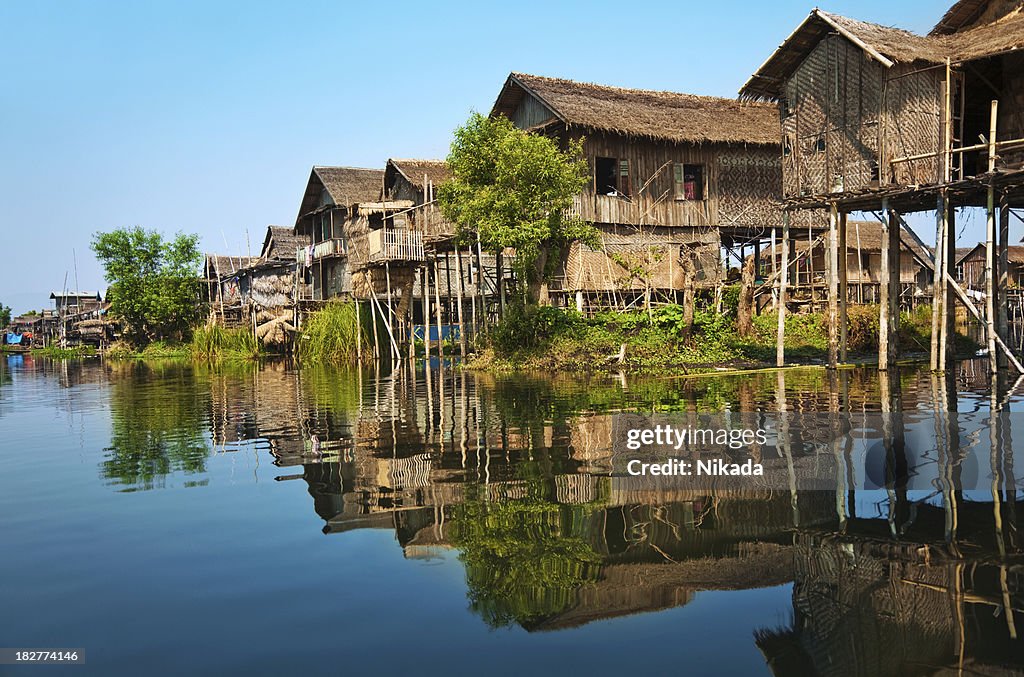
[782,35,944,198]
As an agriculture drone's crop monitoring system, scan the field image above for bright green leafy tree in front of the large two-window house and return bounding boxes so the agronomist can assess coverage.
[437,113,596,302]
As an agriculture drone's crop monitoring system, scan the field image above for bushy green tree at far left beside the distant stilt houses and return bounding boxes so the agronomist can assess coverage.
[92,226,202,343]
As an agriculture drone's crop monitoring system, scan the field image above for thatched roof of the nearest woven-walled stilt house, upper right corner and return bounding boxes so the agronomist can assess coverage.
[739,5,1024,100]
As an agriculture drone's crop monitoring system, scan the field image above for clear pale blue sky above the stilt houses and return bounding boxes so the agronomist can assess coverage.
[0,0,983,311]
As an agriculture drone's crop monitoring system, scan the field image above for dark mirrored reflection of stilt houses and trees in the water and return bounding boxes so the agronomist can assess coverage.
[188,356,1024,675]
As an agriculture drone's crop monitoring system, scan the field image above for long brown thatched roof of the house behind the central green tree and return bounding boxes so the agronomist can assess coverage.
[490,73,779,145]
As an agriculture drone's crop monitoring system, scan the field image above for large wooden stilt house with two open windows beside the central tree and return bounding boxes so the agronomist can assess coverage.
[492,73,781,304]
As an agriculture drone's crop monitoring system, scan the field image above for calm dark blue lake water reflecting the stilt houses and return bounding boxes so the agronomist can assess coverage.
[0,356,1024,675]
